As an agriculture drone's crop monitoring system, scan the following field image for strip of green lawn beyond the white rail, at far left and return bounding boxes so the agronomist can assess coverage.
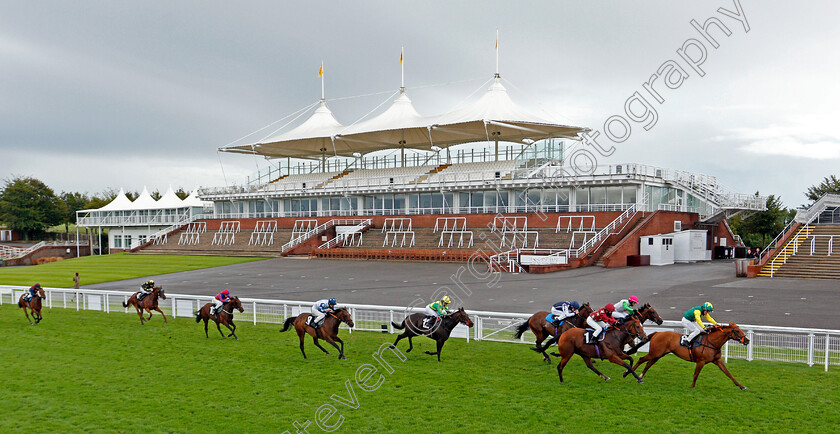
[0,253,260,288]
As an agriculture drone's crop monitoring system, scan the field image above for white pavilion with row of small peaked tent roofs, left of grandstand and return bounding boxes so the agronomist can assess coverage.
[76,186,210,252]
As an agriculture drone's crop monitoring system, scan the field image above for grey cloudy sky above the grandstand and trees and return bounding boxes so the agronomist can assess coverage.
[0,0,840,206]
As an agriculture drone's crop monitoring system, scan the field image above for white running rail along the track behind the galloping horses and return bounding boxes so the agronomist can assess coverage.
[0,286,840,371]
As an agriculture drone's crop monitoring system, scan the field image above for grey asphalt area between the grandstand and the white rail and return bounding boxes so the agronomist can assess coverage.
[90,258,840,329]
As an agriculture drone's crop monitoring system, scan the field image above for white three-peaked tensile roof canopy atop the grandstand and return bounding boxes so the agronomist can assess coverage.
[219,74,588,158]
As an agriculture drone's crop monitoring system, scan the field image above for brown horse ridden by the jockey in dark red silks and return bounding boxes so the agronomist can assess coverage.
[557,316,647,383]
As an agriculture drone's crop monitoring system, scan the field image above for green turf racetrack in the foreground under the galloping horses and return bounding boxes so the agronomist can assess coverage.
[0,305,840,433]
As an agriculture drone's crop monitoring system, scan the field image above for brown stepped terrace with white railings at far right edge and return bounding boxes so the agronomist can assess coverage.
[759,225,840,279]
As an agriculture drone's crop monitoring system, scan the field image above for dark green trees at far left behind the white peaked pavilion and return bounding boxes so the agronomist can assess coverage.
[0,176,189,240]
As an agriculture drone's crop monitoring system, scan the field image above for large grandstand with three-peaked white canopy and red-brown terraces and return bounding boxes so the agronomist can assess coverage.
[79,73,765,272]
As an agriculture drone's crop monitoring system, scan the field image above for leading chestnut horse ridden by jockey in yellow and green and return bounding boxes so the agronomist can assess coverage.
[624,323,750,390]
